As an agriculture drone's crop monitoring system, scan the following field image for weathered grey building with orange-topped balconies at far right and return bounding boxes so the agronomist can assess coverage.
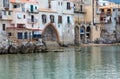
[99,5,120,41]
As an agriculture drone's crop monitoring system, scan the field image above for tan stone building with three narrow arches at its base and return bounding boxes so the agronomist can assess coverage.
[73,0,100,43]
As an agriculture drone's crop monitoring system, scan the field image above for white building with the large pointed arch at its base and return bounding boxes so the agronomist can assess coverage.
[39,0,74,44]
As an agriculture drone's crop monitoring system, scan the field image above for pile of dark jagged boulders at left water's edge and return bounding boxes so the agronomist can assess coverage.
[0,42,47,54]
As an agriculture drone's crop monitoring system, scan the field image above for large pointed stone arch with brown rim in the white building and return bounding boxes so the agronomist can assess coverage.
[42,24,59,42]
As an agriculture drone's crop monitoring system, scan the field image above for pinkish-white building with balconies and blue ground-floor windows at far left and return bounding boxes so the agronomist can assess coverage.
[0,0,40,43]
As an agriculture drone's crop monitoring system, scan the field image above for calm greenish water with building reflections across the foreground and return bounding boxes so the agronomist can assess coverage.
[0,46,120,79]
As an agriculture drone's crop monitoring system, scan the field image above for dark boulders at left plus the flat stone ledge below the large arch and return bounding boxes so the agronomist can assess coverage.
[0,41,64,54]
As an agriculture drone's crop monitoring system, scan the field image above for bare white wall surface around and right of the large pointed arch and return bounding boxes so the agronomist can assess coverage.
[39,0,74,44]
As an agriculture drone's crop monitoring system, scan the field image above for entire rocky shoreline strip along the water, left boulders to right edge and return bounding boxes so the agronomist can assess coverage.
[0,41,120,54]
